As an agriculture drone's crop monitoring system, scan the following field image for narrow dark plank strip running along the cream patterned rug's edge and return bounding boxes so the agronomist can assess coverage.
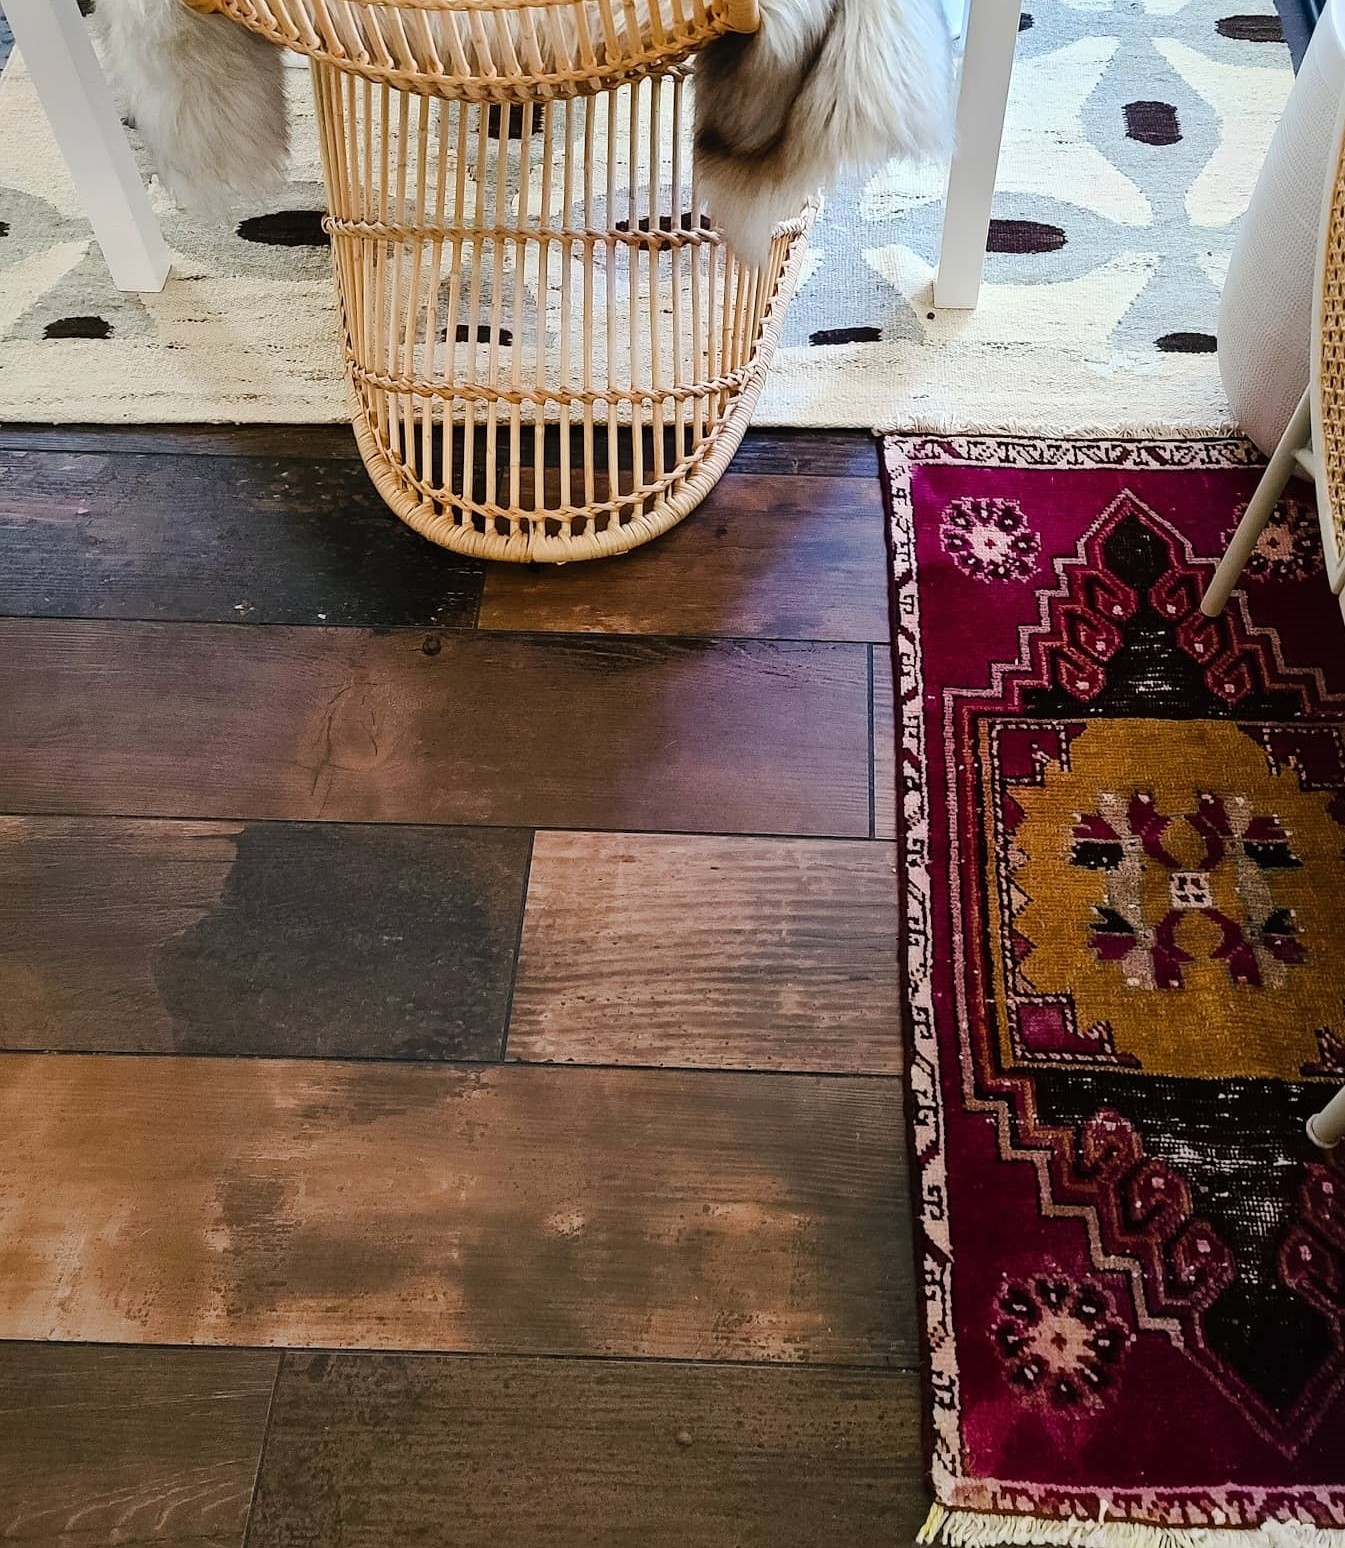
[0,424,878,478]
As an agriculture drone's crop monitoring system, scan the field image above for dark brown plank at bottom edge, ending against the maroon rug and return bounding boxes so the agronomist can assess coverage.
[249,1355,927,1548]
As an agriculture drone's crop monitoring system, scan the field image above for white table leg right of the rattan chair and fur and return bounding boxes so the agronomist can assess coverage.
[933,0,1022,311]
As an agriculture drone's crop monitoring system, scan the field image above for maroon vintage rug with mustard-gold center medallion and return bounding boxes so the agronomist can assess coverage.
[885,438,1345,1545]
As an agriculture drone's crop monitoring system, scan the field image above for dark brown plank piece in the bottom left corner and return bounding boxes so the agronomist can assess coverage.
[0,1344,280,1548]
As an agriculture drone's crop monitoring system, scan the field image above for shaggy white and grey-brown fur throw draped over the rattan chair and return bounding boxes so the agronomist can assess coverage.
[94,0,952,262]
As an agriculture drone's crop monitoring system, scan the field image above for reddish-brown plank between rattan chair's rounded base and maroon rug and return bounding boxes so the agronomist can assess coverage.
[480,474,887,641]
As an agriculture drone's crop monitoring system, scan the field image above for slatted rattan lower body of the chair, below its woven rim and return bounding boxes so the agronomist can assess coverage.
[313,60,816,563]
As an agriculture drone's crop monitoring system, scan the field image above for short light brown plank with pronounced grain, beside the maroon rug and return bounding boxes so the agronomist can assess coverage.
[508,833,902,1077]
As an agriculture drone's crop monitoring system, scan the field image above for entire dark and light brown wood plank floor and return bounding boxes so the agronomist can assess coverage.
[0,426,926,1548]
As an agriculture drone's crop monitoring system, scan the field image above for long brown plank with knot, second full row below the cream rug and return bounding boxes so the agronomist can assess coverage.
[0,619,868,837]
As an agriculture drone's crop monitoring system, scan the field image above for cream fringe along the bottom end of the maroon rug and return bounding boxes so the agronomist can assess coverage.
[915,1503,1345,1548]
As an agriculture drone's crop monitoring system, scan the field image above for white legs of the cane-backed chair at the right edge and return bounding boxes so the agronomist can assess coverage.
[1200,81,1345,1150]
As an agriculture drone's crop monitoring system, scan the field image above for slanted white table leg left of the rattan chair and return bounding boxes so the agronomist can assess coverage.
[5,0,170,291]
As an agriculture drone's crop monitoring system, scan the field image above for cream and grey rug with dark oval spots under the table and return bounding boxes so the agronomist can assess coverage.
[0,0,1292,435]
